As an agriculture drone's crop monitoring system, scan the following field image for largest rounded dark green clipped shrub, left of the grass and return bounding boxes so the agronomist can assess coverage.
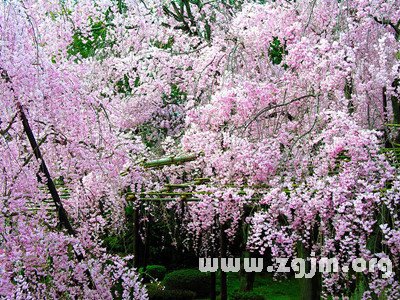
[163,269,211,297]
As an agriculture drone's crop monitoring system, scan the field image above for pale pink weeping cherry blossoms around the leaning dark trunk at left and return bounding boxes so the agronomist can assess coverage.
[0,1,151,299]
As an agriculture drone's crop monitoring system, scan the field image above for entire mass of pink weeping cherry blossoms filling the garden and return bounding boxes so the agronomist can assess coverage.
[0,0,400,299]
